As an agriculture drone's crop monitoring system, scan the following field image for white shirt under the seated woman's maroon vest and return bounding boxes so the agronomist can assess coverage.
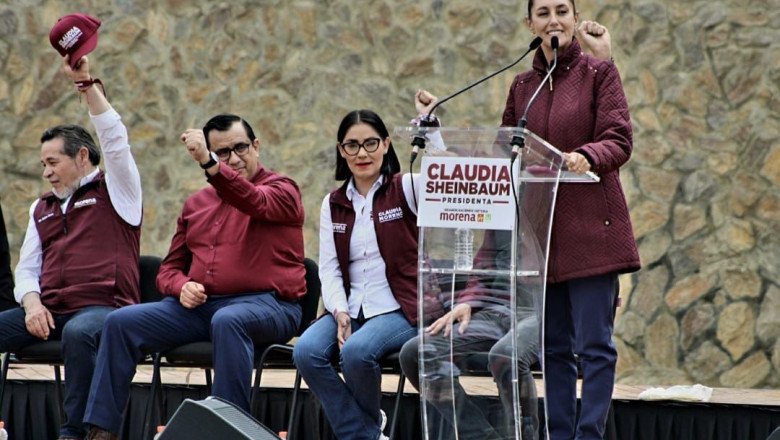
[319,174,419,318]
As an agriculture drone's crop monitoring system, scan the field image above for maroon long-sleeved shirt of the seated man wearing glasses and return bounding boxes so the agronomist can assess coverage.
[157,163,306,301]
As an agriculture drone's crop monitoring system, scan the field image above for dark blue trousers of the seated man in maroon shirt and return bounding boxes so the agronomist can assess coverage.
[84,293,301,434]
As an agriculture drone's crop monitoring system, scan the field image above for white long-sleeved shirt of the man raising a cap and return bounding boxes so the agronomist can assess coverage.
[14,108,143,304]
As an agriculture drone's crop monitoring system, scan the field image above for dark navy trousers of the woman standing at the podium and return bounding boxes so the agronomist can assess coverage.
[544,274,619,440]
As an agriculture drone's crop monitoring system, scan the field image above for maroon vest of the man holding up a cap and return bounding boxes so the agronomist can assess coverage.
[33,171,141,314]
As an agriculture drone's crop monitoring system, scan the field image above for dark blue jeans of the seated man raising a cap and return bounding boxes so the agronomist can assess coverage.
[0,306,115,437]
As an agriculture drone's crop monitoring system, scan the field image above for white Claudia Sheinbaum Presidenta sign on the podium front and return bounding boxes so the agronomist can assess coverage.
[417,155,518,230]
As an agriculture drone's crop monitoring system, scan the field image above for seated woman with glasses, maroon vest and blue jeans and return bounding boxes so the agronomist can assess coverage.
[294,110,438,440]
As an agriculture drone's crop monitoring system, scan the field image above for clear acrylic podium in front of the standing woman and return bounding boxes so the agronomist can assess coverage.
[394,127,598,440]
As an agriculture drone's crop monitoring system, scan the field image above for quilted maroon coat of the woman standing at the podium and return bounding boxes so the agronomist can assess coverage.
[502,39,640,282]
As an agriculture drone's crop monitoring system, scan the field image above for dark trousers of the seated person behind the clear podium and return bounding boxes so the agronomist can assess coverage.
[400,307,539,440]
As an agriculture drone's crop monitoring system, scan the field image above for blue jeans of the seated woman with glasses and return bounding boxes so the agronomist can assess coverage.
[293,310,417,440]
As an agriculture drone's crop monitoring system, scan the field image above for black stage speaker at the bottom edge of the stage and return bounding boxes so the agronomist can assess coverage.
[159,397,280,440]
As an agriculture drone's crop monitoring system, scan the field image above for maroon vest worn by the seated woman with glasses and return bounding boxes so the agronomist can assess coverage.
[330,173,443,325]
